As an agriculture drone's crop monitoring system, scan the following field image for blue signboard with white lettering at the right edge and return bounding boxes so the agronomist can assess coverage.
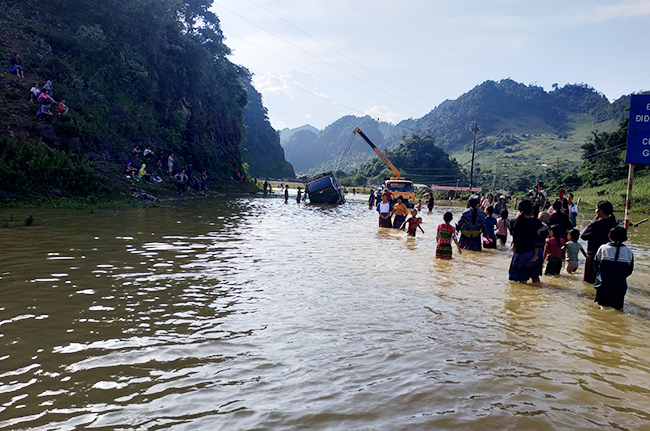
[625,94,650,165]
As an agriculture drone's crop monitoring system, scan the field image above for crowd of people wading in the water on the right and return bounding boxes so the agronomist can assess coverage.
[377,194,634,310]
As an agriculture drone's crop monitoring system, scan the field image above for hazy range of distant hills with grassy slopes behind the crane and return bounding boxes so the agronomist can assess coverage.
[283,79,630,187]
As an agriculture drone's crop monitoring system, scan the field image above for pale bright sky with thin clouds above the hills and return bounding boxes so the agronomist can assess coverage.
[211,0,650,130]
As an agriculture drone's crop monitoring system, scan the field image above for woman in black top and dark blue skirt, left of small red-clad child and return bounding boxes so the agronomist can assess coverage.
[508,199,543,283]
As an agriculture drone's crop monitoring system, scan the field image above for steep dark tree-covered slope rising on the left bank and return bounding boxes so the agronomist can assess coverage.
[0,0,287,203]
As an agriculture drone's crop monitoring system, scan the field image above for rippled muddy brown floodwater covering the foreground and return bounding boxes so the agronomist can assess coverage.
[0,196,650,431]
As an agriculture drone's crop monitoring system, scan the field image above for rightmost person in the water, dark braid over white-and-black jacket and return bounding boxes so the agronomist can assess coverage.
[594,226,634,310]
